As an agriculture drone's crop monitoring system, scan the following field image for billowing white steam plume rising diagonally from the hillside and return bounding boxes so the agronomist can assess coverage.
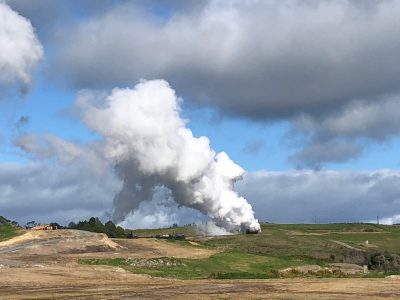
[77,80,260,231]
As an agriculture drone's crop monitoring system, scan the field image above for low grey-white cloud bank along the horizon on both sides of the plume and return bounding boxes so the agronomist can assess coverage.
[0,161,400,228]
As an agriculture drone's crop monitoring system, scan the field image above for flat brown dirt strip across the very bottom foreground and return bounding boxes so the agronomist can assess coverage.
[0,266,400,300]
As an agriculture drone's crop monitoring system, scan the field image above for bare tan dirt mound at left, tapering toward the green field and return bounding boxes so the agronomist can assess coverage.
[0,230,216,269]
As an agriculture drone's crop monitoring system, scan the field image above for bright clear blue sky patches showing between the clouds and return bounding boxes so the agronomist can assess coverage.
[0,81,400,172]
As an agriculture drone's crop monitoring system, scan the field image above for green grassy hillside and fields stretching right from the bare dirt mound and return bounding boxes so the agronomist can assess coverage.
[82,224,400,279]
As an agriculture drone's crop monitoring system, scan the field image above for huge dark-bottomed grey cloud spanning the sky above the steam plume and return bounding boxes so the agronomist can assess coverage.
[53,1,400,120]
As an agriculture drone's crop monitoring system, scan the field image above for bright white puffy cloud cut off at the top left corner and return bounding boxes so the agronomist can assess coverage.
[0,2,43,90]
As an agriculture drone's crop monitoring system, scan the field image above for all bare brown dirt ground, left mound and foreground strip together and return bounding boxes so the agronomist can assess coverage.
[0,230,400,299]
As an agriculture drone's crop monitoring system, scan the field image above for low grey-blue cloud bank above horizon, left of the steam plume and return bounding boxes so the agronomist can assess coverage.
[0,161,120,224]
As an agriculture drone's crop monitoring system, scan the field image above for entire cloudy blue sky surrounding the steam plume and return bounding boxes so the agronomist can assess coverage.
[0,0,400,227]
